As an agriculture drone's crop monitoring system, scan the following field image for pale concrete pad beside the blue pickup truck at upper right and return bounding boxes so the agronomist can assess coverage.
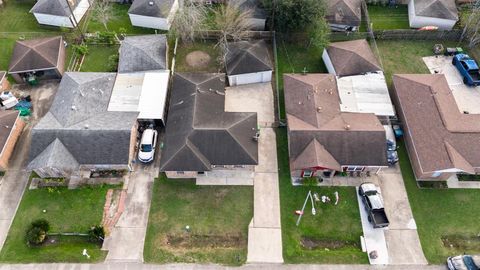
[423,56,480,114]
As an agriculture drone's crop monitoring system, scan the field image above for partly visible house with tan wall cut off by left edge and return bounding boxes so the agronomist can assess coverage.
[0,110,25,171]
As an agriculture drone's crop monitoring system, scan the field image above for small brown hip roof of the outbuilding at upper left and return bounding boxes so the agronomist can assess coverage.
[8,36,64,73]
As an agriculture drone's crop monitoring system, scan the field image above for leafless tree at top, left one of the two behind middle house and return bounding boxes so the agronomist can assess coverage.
[171,0,208,43]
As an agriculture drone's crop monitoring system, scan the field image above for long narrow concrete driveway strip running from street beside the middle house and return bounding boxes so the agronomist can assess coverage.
[247,128,283,263]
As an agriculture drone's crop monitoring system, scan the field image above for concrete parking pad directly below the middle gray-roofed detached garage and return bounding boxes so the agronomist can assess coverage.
[225,83,275,127]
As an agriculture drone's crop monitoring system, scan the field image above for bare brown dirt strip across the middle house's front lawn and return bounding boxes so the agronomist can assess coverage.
[166,234,246,249]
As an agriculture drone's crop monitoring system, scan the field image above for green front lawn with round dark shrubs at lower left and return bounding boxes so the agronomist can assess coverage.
[0,186,111,263]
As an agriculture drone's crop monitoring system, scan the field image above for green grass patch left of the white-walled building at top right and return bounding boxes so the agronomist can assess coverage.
[368,5,410,30]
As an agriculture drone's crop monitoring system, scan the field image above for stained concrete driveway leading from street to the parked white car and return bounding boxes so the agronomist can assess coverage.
[102,164,158,263]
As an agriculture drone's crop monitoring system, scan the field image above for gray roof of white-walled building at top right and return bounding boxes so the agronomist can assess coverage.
[414,0,458,20]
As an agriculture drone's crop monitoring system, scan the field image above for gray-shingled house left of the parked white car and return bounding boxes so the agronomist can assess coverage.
[28,72,138,178]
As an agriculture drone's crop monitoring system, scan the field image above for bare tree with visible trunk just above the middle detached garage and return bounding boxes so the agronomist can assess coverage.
[214,1,253,63]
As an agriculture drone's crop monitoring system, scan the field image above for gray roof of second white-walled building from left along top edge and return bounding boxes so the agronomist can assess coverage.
[128,0,175,18]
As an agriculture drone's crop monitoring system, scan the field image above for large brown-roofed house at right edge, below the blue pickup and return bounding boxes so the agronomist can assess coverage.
[393,74,480,180]
